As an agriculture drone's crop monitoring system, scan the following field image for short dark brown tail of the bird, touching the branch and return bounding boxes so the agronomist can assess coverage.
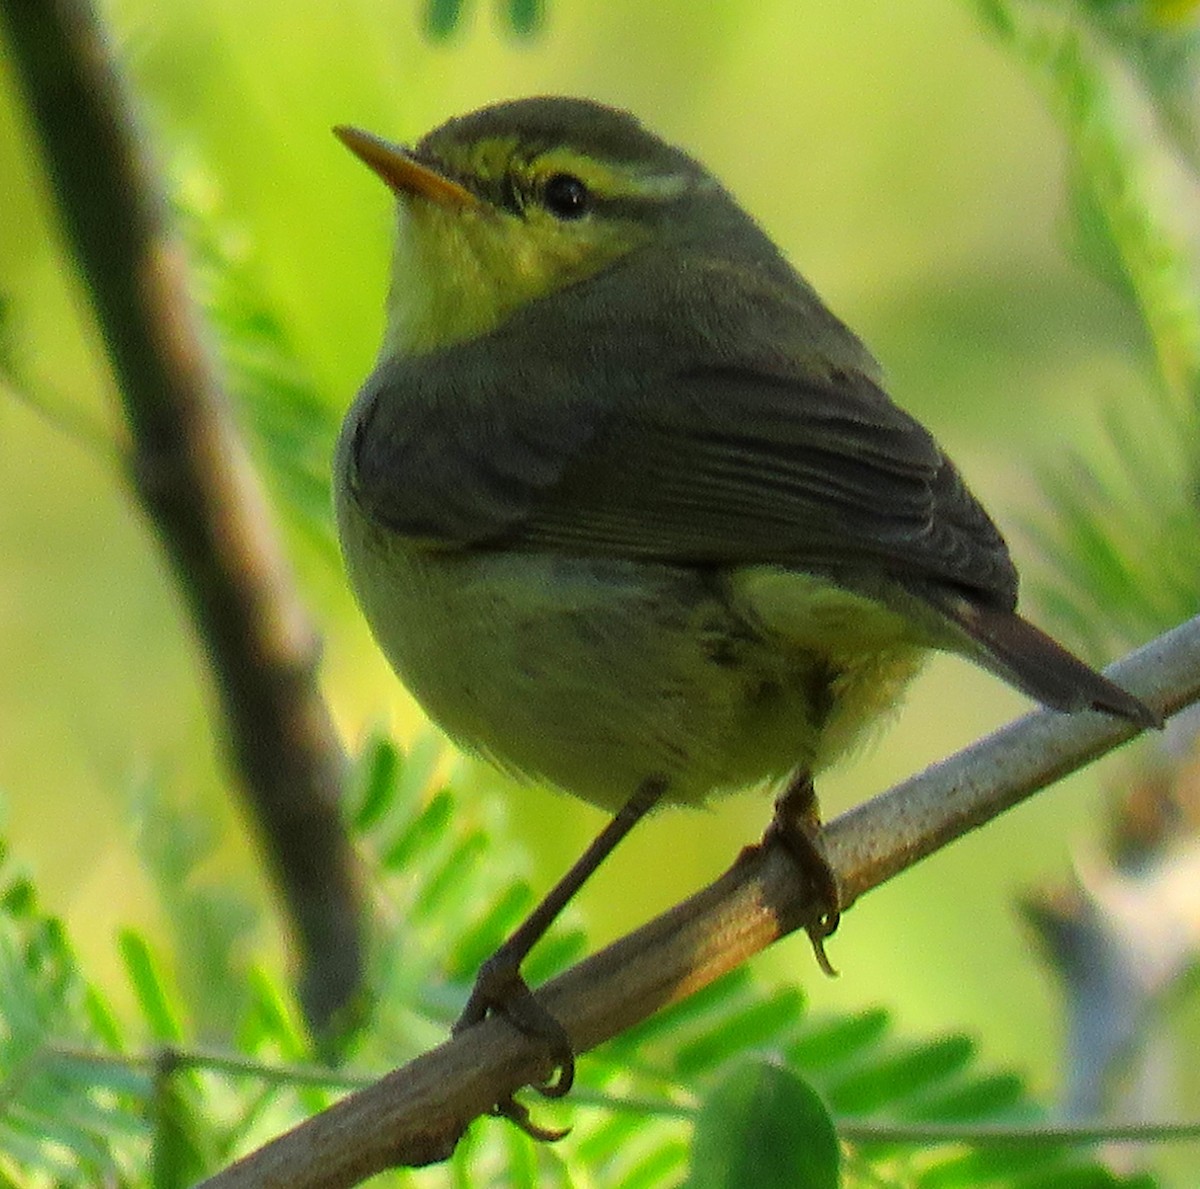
[938,599,1163,728]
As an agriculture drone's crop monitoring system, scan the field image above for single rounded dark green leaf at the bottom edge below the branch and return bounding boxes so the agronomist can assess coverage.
[685,1061,840,1189]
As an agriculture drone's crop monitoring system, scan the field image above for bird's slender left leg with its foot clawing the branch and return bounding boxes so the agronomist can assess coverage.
[452,777,666,1118]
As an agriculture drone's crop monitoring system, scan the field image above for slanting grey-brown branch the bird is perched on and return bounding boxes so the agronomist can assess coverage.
[205,617,1200,1189]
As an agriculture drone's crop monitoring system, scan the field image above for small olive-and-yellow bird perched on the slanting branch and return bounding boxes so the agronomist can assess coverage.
[335,98,1158,1113]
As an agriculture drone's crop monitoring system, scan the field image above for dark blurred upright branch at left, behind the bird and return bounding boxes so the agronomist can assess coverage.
[0,0,362,1027]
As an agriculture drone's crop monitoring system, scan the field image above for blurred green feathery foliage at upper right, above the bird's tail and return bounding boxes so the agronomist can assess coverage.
[980,0,1200,659]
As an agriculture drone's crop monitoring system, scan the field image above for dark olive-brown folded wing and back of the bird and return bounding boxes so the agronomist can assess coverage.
[353,250,1016,607]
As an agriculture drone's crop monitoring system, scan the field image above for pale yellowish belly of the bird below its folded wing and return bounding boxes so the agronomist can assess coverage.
[338,504,924,811]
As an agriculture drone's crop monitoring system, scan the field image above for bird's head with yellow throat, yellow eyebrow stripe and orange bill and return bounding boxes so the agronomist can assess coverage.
[335,98,757,355]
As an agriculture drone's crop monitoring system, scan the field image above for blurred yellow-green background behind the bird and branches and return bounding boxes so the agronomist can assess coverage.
[0,0,1200,1180]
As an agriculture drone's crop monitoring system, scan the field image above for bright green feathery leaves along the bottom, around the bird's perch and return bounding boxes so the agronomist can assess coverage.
[0,738,1171,1189]
